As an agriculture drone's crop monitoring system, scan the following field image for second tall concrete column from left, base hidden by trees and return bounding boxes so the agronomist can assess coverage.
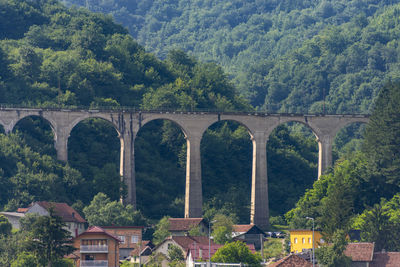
[120,132,136,209]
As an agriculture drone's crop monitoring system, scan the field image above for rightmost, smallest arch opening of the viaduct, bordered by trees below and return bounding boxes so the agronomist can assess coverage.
[332,122,366,162]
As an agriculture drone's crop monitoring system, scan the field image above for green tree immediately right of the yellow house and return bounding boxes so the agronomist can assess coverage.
[315,230,351,267]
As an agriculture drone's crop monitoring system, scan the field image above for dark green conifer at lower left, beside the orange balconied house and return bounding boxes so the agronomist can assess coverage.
[28,208,75,267]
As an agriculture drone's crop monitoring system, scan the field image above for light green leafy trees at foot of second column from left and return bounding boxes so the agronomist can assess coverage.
[83,193,147,226]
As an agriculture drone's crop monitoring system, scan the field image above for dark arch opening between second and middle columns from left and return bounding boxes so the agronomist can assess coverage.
[134,118,187,219]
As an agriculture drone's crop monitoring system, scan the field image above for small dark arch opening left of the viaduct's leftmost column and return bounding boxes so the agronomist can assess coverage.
[12,115,57,157]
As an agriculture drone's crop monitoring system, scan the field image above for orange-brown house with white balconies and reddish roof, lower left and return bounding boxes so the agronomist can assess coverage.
[73,226,121,267]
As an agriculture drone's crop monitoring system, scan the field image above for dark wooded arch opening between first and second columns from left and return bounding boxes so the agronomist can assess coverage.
[67,117,121,204]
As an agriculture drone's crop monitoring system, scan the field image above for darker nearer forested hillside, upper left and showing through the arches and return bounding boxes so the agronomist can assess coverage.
[0,0,317,222]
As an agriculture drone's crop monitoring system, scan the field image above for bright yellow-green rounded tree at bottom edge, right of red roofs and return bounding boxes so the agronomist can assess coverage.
[211,241,262,266]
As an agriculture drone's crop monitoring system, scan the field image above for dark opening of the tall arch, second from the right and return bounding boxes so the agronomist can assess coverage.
[267,120,319,217]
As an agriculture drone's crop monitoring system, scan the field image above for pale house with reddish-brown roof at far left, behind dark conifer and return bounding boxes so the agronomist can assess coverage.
[0,201,86,237]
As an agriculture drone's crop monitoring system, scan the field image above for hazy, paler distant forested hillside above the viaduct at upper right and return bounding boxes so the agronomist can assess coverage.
[63,0,399,113]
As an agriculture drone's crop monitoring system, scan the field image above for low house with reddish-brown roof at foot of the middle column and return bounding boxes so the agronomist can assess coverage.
[168,218,208,236]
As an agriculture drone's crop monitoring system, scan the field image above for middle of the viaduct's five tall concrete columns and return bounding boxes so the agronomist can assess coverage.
[185,134,203,218]
